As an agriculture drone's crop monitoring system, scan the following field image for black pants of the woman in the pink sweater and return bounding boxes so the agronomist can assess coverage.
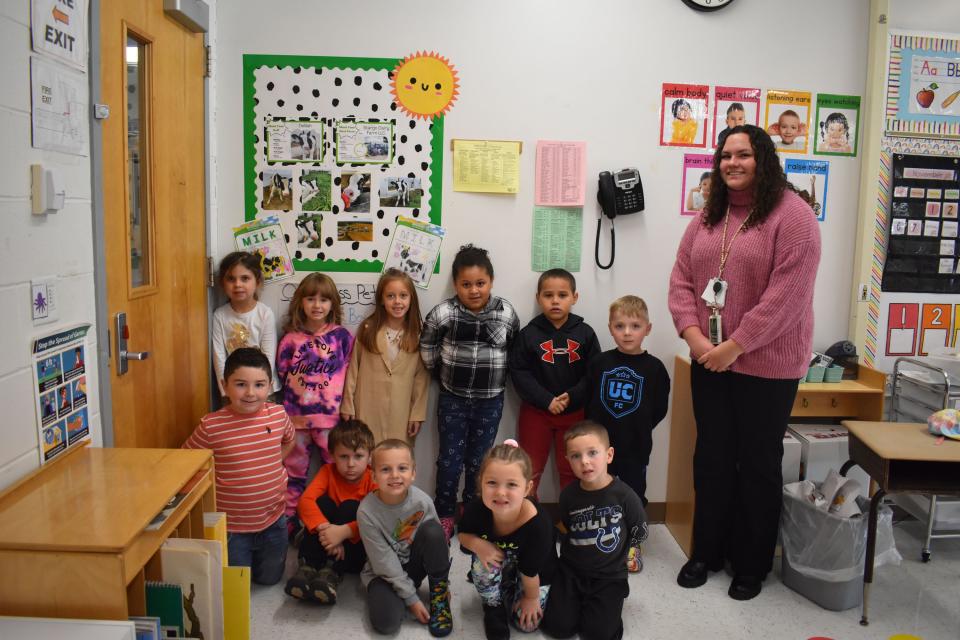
[690,363,798,578]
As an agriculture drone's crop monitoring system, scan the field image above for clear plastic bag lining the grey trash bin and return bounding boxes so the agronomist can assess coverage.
[780,483,901,582]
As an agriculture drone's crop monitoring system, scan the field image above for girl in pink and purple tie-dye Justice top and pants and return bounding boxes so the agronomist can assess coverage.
[277,273,353,538]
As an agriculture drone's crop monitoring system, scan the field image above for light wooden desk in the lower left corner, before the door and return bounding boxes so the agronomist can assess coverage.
[0,447,216,620]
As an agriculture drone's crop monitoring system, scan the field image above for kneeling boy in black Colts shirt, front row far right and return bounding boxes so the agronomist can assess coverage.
[541,420,647,640]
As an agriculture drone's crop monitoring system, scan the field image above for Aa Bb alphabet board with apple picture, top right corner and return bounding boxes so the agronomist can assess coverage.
[885,29,960,140]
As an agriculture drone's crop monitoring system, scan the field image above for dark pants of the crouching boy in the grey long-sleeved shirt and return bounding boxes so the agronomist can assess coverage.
[367,520,450,634]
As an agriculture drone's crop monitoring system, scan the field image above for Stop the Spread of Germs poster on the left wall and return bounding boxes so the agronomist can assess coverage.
[31,324,90,465]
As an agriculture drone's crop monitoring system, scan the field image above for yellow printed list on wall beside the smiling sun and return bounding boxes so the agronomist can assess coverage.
[453,140,520,193]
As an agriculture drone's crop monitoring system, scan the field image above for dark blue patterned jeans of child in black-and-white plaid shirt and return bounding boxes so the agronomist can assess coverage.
[434,391,503,518]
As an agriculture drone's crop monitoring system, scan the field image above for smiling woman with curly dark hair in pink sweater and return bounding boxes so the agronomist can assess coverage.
[669,125,820,600]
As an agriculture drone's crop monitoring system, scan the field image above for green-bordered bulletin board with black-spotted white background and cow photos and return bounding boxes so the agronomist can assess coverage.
[243,54,443,272]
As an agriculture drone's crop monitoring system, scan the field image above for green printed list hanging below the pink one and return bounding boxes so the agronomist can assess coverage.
[530,207,583,272]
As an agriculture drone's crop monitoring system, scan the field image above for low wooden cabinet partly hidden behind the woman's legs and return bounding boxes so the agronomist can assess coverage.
[666,356,886,557]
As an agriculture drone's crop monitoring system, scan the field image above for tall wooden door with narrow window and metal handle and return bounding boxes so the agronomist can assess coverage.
[100,0,210,447]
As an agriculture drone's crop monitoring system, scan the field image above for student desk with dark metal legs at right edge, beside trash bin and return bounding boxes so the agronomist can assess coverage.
[841,420,960,626]
